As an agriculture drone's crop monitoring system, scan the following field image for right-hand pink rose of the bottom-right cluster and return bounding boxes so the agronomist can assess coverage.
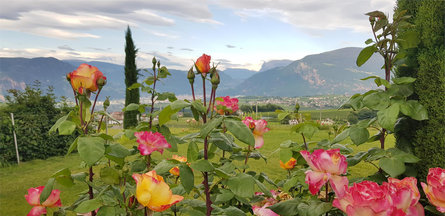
[382,177,425,216]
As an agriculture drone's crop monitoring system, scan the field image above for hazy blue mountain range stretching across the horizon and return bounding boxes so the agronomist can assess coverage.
[0,47,383,101]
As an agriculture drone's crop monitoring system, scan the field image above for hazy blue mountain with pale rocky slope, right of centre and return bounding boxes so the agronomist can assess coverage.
[225,47,383,96]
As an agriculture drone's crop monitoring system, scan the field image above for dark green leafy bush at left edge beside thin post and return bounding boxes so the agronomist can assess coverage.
[0,83,74,163]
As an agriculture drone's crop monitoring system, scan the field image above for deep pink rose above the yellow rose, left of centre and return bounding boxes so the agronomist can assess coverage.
[134,131,172,155]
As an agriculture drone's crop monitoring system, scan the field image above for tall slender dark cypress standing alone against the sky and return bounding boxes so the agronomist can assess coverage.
[124,26,139,129]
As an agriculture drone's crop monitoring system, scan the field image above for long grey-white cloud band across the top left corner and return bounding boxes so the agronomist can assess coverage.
[0,0,218,39]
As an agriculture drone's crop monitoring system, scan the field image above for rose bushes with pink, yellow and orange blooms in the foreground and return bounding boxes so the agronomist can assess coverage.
[25,8,445,216]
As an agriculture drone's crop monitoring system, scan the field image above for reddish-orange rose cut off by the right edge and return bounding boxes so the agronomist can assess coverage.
[420,167,445,213]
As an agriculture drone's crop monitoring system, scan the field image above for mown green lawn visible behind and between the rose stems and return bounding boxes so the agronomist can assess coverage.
[0,115,394,215]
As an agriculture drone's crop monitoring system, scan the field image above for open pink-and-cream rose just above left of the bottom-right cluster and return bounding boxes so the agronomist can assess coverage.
[300,149,349,197]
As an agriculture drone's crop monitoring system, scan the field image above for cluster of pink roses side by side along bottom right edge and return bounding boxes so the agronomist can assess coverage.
[332,177,424,216]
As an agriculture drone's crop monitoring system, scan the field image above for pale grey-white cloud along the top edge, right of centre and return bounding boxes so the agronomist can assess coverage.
[214,0,395,31]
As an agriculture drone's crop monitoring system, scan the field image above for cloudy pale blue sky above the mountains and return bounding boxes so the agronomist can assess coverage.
[0,0,395,70]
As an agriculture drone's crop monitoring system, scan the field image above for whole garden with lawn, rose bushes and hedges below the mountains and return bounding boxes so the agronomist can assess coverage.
[0,1,445,216]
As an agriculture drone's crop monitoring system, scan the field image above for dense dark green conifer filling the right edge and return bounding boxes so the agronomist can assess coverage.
[396,0,445,181]
